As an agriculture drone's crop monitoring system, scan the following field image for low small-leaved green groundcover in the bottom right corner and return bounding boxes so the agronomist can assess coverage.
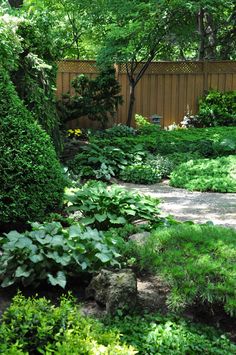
[108,314,236,355]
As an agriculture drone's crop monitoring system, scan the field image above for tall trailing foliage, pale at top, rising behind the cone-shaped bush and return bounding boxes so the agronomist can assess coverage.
[0,7,61,151]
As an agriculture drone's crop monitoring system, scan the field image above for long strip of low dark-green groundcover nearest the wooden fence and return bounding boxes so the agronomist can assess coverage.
[90,127,236,157]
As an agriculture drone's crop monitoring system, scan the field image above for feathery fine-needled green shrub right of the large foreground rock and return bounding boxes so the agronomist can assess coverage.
[122,224,236,316]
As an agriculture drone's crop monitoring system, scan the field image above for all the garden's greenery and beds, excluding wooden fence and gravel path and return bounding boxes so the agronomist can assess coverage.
[0,0,236,355]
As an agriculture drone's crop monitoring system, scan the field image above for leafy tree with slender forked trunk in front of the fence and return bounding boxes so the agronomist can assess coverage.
[95,0,189,126]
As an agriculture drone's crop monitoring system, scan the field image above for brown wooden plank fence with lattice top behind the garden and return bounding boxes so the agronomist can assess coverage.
[57,60,236,128]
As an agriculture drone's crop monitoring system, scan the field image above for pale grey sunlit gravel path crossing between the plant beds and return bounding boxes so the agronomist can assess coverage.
[119,181,236,228]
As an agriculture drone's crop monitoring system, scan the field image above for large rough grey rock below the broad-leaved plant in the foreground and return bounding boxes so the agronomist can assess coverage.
[86,269,137,314]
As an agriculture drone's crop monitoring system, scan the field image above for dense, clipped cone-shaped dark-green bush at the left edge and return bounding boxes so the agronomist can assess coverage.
[0,71,66,231]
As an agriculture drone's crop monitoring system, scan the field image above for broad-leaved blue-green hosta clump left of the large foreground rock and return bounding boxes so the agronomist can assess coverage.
[0,222,119,288]
